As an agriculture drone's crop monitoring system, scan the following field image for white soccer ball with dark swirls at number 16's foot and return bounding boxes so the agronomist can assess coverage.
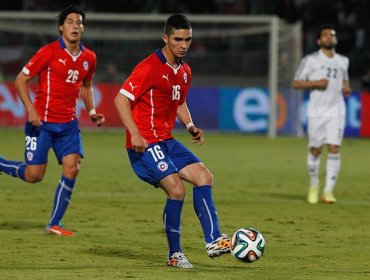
[230,227,265,263]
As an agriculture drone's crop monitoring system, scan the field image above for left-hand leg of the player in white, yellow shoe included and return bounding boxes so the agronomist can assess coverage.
[306,118,325,204]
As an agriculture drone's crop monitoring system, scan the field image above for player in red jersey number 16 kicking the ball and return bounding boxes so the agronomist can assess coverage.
[115,14,230,268]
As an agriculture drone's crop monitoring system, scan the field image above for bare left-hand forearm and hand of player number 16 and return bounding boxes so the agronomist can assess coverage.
[114,92,148,153]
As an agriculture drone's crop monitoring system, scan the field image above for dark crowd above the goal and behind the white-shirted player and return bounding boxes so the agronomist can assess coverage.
[0,0,370,90]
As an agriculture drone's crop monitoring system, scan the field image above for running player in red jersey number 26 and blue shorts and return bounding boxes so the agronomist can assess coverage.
[0,6,105,236]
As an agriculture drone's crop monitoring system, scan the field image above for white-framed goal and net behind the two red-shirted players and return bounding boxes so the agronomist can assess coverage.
[0,12,302,137]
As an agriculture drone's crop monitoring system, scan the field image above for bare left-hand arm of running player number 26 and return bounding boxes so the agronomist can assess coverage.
[15,71,42,126]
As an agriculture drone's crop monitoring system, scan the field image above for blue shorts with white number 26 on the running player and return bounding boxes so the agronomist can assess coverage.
[24,120,83,165]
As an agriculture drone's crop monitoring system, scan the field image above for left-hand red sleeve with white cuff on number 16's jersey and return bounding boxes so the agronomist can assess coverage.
[120,60,153,101]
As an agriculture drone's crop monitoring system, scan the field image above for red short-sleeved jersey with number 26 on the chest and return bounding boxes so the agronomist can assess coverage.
[22,37,96,123]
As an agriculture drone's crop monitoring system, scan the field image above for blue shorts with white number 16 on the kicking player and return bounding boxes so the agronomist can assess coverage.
[127,139,200,187]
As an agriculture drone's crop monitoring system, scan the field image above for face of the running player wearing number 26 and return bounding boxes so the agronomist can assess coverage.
[59,13,84,43]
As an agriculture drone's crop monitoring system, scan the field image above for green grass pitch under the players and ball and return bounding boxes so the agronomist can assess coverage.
[0,128,370,279]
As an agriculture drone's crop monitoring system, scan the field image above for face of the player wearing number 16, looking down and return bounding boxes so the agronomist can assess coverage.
[163,29,192,58]
